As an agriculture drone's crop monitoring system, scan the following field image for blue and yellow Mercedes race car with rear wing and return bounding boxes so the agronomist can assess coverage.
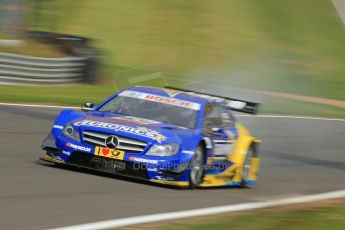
[40,86,260,188]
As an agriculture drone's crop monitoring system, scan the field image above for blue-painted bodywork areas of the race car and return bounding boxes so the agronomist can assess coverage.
[47,86,238,186]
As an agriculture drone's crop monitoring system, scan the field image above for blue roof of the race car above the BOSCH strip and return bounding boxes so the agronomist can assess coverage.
[124,86,209,106]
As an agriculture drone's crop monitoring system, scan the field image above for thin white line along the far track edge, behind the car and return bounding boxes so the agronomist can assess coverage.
[0,102,345,121]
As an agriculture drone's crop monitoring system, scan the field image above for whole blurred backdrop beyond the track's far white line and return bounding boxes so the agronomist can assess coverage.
[0,0,345,117]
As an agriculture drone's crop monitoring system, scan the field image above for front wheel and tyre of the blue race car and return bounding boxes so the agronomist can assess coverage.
[189,145,204,189]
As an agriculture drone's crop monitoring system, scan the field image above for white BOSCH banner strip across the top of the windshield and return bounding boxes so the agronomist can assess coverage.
[119,90,201,110]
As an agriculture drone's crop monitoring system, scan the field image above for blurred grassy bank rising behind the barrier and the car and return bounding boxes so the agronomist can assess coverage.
[28,0,345,100]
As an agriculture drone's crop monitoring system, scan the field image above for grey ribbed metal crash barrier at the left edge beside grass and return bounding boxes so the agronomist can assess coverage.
[0,52,87,85]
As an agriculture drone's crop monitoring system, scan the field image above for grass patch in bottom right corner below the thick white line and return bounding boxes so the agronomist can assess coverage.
[137,200,345,230]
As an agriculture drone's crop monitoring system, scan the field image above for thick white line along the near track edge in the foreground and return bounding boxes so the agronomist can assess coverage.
[51,190,345,230]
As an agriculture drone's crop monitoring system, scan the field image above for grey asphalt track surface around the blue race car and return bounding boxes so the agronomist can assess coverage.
[0,105,345,229]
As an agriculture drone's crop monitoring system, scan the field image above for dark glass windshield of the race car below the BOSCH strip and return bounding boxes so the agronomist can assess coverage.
[98,93,198,129]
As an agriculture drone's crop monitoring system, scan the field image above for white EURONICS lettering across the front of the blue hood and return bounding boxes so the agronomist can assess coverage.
[74,120,166,143]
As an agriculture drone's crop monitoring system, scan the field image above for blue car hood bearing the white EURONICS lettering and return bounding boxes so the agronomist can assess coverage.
[70,111,194,144]
